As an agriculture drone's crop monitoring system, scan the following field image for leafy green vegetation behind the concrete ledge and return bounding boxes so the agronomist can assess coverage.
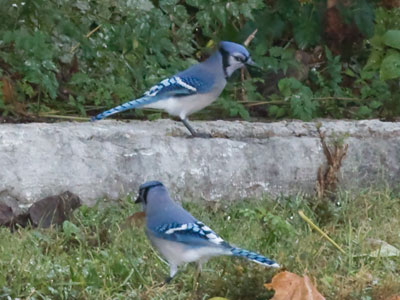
[0,0,400,121]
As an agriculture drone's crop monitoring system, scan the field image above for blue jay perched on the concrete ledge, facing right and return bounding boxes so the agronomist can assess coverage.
[92,42,255,137]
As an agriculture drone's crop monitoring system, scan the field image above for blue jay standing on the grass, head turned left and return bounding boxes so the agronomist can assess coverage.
[135,181,279,282]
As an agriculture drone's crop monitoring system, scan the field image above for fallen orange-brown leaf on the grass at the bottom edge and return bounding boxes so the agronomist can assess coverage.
[264,271,325,300]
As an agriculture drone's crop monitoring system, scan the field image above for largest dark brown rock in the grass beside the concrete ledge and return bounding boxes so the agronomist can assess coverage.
[28,192,81,228]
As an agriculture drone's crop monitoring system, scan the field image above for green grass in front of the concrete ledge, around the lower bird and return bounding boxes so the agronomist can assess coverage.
[0,190,400,300]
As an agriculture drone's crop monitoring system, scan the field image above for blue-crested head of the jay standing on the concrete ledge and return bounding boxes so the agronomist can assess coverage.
[218,41,254,77]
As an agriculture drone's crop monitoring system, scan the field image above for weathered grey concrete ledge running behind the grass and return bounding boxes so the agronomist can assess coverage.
[0,120,400,207]
